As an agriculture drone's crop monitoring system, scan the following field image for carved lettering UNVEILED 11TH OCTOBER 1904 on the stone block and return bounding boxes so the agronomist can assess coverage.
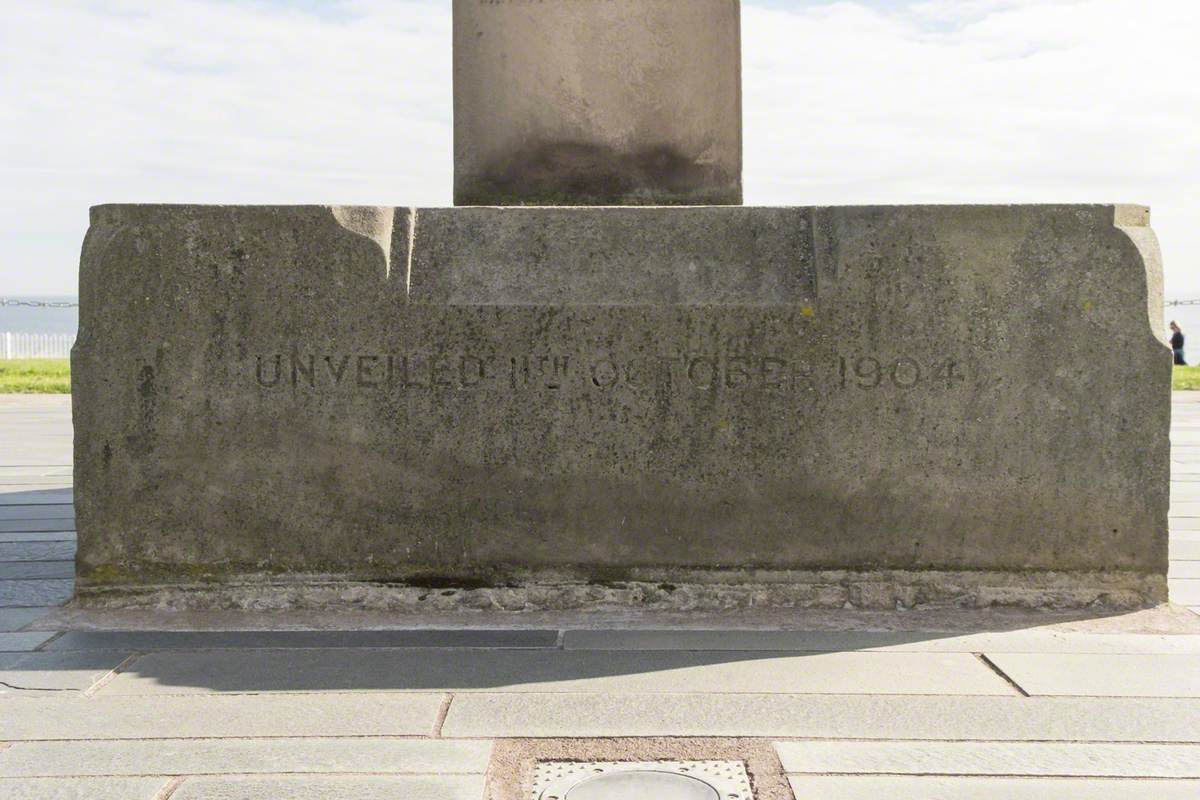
[250,353,966,391]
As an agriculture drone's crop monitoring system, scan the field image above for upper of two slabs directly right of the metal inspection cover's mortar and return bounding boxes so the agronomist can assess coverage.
[775,741,1200,778]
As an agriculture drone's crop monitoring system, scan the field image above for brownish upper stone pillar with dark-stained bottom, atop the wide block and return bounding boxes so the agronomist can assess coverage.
[454,0,742,205]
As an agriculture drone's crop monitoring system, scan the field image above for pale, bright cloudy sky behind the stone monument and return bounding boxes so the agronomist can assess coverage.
[0,0,1200,299]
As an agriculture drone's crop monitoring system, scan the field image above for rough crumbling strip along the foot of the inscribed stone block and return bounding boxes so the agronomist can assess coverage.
[76,570,1166,615]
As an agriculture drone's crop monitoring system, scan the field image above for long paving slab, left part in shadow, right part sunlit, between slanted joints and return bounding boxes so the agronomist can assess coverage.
[96,643,1014,696]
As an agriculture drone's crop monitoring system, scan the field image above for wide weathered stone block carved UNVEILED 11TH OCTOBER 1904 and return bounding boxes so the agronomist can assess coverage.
[72,206,1170,607]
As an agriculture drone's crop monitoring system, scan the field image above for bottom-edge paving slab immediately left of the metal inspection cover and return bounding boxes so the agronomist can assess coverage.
[170,775,485,800]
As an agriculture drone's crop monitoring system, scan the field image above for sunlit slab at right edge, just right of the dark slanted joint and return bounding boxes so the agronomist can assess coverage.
[988,652,1200,697]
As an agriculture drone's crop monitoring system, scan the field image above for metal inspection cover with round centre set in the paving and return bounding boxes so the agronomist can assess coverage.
[532,762,754,800]
